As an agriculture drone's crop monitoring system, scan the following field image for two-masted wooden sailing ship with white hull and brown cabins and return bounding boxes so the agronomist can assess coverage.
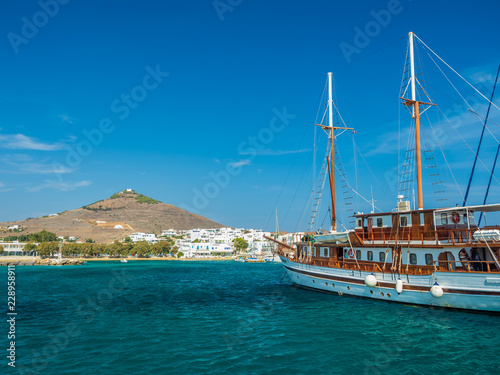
[269,33,500,312]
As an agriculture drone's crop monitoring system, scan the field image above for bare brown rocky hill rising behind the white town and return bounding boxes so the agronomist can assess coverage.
[0,190,223,243]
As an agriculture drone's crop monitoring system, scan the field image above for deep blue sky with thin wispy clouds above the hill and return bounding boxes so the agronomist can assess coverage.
[0,0,500,231]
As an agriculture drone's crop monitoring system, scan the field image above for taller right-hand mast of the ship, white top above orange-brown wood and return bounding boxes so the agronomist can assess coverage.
[400,32,435,210]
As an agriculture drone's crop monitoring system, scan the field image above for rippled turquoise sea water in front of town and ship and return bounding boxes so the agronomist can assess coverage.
[0,261,500,375]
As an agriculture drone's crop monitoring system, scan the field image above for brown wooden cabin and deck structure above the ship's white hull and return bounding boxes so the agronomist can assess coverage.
[281,205,500,275]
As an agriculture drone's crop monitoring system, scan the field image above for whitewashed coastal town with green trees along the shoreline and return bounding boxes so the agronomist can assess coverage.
[0,226,304,259]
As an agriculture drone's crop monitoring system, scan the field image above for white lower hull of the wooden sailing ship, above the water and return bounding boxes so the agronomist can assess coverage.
[281,256,500,312]
